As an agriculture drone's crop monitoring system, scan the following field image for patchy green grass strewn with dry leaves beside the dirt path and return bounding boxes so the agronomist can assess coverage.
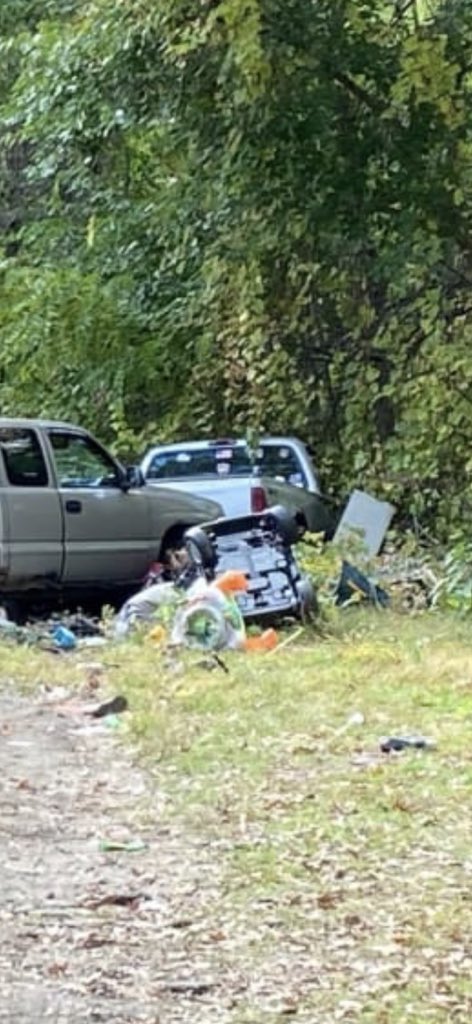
[8,611,472,1024]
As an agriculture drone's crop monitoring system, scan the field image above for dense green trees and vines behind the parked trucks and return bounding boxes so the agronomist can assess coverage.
[0,0,472,539]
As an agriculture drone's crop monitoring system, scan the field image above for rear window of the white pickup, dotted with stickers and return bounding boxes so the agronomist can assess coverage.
[146,444,307,487]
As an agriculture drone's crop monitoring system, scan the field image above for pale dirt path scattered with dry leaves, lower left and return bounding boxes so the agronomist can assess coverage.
[0,690,239,1024]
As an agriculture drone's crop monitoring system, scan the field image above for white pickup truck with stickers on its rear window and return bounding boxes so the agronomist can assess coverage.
[140,437,332,532]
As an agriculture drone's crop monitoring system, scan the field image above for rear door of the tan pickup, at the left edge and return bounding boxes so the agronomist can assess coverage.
[0,426,63,586]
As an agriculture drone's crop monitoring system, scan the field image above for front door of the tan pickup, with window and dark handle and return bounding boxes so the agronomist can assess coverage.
[48,428,153,585]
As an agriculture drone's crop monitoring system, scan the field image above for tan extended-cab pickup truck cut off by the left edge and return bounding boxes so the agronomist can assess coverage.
[0,418,221,601]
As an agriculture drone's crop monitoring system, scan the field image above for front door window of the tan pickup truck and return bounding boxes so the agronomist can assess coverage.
[49,430,118,488]
